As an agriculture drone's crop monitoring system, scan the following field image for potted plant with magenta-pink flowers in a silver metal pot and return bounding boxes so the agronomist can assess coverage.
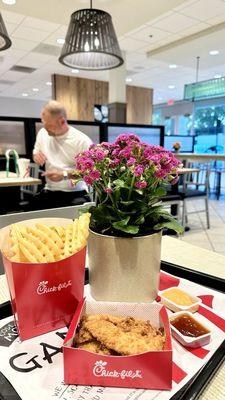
[74,134,183,301]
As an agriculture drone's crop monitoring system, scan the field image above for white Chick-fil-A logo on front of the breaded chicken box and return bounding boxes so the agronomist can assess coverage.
[93,360,142,379]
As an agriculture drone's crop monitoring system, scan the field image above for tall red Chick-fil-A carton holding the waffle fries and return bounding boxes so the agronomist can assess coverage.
[1,218,86,340]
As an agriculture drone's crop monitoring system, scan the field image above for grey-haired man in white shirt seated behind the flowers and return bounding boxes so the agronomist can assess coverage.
[31,101,92,209]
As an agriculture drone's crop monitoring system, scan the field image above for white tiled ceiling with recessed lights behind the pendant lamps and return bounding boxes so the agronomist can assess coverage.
[0,0,225,103]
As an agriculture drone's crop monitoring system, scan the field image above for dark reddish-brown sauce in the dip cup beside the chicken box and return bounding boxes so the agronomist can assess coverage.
[170,314,209,337]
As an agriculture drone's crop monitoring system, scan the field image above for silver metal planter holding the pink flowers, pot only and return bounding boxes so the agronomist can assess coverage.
[88,231,162,302]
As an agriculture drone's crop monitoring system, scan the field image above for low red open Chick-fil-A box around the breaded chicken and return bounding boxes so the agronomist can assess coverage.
[63,300,172,390]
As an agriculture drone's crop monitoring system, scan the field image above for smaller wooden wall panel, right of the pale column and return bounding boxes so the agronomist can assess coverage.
[126,86,153,124]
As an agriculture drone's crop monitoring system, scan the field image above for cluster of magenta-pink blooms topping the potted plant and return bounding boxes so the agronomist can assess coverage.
[75,133,180,193]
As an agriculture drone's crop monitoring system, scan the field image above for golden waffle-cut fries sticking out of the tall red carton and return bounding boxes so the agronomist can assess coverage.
[3,213,90,263]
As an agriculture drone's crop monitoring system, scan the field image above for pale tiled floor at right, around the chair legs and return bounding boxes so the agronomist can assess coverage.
[181,196,225,256]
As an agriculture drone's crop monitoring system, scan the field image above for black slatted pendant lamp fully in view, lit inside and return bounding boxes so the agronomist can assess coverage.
[59,1,124,71]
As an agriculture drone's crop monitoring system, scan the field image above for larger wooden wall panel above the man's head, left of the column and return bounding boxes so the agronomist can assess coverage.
[53,75,109,121]
